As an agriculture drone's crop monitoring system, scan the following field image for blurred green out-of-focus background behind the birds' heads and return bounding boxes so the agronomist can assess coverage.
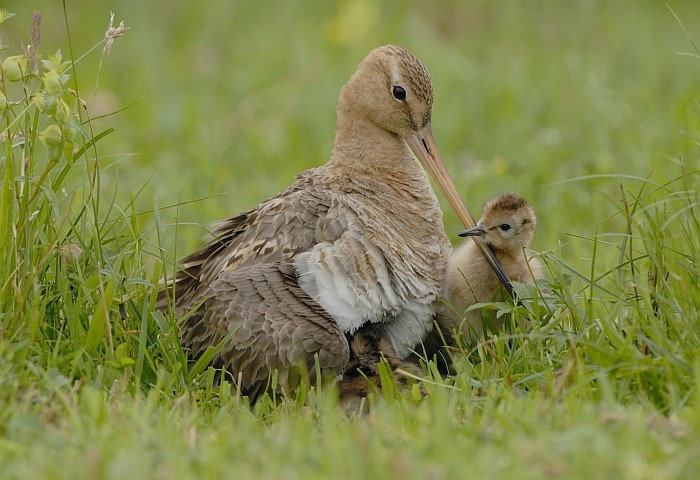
[2,0,700,265]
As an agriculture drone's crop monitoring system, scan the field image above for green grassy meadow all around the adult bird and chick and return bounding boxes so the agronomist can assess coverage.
[0,0,700,479]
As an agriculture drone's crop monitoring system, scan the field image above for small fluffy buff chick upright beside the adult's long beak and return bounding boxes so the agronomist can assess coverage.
[440,193,544,339]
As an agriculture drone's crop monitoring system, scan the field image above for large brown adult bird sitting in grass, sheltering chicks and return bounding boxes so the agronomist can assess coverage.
[158,46,464,397]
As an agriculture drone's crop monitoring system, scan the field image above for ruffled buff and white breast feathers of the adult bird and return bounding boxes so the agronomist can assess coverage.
[294,186,450,358]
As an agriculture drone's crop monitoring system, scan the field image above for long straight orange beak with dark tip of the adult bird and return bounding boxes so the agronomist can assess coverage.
[406,122,513,295]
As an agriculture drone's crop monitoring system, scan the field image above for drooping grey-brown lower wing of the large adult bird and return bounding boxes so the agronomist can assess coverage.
[181,263,349,390]
